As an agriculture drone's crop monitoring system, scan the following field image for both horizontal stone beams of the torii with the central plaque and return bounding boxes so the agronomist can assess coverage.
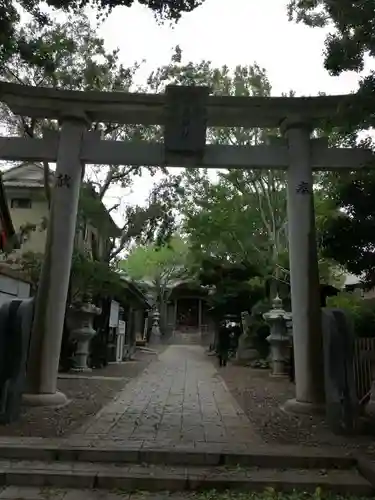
[0,83,374,170]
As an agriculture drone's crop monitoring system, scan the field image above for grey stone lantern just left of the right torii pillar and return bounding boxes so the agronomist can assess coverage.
[263,296,292,377]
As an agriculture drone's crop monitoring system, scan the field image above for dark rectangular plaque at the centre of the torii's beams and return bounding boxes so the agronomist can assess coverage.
[164,85,209,163]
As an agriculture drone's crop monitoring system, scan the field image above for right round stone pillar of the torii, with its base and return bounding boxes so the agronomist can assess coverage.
[283,117,325,414]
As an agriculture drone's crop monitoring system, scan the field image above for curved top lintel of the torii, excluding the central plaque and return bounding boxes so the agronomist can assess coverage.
[0,82,368,128]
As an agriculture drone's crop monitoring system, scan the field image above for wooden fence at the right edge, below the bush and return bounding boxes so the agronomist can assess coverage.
[354,337,375,404]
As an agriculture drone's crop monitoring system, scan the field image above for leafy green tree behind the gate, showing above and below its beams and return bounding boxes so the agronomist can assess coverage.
[148,47,287,292]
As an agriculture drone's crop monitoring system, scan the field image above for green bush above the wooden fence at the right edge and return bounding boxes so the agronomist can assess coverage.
[327,292,375,337]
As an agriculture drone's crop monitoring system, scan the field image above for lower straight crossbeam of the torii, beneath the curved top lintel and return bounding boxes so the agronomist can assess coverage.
[0,131,374,170]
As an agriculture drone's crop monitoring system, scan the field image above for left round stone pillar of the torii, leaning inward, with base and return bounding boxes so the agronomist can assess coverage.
[24,111,88,405]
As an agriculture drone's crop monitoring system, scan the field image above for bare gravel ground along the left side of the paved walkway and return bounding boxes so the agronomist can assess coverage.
[0,351,156,437]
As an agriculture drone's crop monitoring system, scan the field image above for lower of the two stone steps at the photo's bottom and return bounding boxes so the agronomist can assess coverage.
[0,460,375,497]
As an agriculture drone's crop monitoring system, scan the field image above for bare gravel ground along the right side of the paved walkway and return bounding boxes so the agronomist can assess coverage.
[220,365,375,451]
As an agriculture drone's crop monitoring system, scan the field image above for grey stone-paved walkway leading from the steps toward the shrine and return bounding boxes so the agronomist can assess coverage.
[70,345,260,449]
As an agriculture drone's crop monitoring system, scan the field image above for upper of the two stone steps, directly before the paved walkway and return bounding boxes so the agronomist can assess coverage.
[0,441,357,469]
